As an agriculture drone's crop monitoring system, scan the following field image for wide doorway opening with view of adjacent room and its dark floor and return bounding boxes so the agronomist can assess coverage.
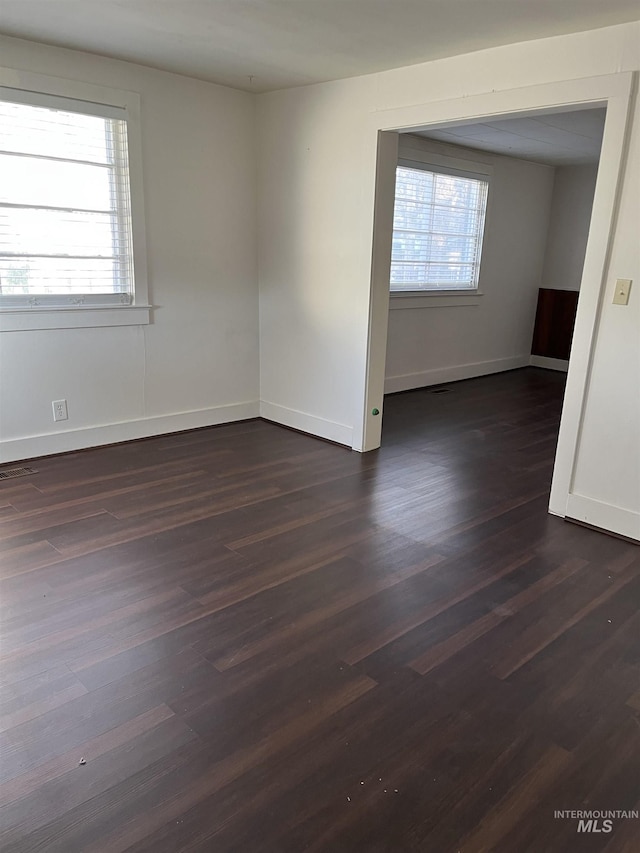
[382,107,606,518]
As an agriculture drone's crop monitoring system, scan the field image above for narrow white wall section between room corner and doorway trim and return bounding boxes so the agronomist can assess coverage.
[258,77,374,445]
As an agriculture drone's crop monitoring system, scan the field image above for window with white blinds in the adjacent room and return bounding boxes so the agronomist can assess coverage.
[391,165,489,292]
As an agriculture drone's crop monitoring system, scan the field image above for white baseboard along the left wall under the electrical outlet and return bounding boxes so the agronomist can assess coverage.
[0,400,260,463]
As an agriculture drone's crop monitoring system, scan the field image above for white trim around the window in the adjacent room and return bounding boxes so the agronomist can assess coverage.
[389,147,493,302]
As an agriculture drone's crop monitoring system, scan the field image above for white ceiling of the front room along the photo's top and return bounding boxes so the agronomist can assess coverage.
[0,0,640,92]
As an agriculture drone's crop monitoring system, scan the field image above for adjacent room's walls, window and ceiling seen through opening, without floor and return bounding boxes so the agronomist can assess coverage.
[385,109,605,393]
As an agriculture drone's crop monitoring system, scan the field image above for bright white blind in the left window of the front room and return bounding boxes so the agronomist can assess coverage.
[0,88,134,307]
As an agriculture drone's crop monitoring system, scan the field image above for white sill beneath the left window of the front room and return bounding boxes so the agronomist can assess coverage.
[0,305,151,332]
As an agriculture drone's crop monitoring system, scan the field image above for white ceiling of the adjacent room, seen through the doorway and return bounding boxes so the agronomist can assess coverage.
[418,109,606,166]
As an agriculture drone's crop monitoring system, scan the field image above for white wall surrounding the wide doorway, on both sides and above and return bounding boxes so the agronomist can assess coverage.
[259,24,640,538]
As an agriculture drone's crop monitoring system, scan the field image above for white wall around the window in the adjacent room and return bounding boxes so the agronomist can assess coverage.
[385,135,554,392]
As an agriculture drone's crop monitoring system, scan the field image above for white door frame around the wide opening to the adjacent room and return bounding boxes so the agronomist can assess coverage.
[354,72,635,526]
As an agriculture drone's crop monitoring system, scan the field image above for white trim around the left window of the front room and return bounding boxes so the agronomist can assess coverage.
[0,67,152,332]
